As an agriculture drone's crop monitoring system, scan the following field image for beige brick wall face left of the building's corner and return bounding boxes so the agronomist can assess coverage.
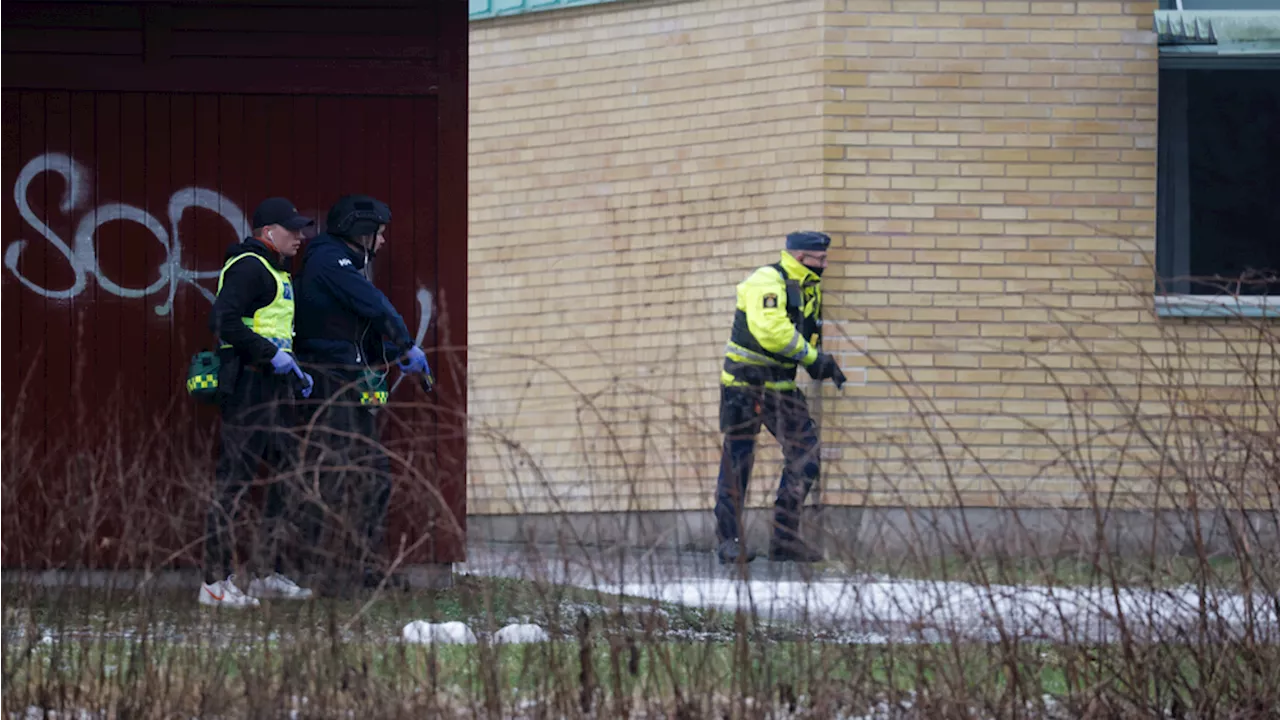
[468,0,823,514]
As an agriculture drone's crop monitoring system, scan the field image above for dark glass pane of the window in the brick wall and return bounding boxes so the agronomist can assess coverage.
[1156,59,1280,296]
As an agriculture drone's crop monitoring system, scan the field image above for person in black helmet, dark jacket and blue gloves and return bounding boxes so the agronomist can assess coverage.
[297,195,430,593]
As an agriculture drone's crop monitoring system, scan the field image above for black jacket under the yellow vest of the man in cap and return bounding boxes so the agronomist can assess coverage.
[209,238,287,365]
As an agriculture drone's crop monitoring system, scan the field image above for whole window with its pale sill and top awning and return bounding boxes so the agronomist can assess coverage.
[1156,0,1280,315]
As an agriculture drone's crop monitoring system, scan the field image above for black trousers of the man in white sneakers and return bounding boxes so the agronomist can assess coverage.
[205,359,298,583]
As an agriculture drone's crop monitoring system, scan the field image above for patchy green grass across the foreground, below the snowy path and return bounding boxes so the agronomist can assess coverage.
[0,566,1280,717]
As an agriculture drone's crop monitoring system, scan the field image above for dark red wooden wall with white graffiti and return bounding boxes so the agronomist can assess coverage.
[0,0,467,566]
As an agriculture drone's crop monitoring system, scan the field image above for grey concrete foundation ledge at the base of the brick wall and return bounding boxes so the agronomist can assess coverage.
[467,507,1280,559]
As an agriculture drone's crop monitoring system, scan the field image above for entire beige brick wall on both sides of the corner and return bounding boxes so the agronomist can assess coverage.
[470,0,1266,514]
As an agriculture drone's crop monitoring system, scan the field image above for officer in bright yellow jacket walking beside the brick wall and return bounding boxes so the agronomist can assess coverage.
[716,231,845,565]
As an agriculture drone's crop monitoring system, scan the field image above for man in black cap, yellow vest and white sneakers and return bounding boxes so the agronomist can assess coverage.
[200,197,314,607]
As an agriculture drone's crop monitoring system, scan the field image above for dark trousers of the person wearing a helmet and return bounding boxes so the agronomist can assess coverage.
[296,365,392,592]
